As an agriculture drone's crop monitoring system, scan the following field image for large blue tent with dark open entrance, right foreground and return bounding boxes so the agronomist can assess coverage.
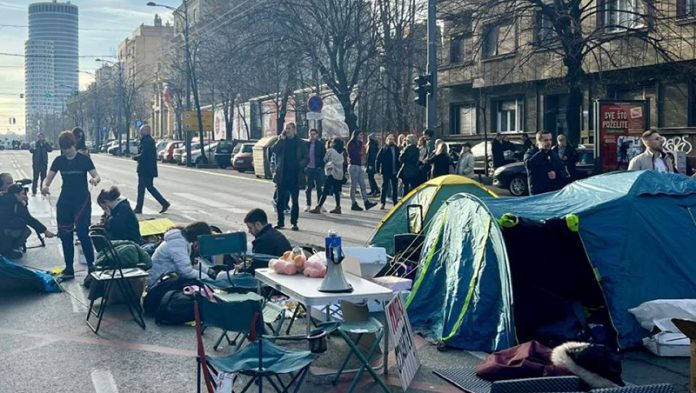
[407,171,696,351]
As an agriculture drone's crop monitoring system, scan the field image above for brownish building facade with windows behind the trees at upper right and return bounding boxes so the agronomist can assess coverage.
[438,0,696,161]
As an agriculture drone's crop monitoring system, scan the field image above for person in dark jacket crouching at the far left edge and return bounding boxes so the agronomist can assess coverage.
[0,184,54,259]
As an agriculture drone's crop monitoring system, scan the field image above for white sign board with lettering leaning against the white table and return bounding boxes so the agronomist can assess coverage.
[386,295,420,392]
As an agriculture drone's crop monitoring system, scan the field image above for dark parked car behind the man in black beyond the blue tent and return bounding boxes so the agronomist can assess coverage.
[493,146,595,196]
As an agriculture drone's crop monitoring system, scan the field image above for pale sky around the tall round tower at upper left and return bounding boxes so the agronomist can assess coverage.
[0,0,174,134]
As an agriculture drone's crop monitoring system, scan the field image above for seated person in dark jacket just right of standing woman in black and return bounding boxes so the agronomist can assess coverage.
[97,186,144,245]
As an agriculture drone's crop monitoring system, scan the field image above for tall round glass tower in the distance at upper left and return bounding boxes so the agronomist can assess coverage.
[25,1,79,139]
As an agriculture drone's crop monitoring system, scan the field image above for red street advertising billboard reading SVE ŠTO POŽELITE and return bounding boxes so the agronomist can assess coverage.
[595,101,647,172]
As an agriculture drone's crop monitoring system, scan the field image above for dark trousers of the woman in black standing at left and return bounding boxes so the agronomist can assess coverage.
[56,194,94,273]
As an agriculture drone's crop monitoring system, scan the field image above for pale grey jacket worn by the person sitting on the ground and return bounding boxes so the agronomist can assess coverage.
[147,229,208,286]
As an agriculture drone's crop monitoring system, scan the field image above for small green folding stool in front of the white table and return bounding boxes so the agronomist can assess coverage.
[333,317,391,393]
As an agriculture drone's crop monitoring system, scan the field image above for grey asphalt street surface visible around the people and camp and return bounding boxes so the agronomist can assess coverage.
[0,151,689,393]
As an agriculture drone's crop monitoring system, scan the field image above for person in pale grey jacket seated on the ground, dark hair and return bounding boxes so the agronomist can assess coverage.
[148,221,212,287]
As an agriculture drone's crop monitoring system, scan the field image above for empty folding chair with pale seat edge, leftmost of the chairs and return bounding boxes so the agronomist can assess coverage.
[86,228,148,334]
